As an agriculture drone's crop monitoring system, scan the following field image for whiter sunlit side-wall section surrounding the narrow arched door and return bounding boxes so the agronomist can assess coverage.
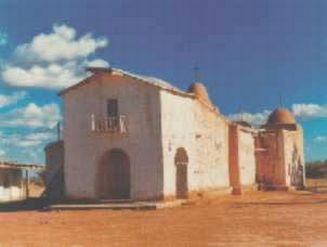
[160,91,197,198]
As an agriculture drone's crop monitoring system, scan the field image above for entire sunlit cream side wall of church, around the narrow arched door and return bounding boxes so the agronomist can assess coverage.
[160,91,229,197]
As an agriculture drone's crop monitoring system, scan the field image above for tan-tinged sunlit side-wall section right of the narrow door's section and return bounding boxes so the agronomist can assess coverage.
[194,100,230,190]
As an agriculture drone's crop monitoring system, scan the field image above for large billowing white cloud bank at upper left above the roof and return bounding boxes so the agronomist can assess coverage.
[1,25,109,89]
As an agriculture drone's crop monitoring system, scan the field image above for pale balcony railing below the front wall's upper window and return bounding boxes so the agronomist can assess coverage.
[91,115,127,134]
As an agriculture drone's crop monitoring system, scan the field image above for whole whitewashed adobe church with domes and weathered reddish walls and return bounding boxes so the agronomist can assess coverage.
[46,68,305,200]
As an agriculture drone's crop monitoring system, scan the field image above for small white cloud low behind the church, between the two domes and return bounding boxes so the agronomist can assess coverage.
[227,110,271,126]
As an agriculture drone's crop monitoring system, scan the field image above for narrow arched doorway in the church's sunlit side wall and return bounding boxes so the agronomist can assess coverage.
[175,147,188,199]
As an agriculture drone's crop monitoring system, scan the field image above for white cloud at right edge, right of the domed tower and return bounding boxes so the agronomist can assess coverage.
[292,103,327,118]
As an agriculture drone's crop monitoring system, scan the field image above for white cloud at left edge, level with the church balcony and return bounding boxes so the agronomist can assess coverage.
[0,103,61,128]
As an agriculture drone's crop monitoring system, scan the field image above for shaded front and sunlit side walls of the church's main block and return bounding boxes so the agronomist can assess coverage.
[61,67,230,200]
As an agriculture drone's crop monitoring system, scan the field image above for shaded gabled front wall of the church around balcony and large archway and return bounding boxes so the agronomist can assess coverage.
[63,74,162,199]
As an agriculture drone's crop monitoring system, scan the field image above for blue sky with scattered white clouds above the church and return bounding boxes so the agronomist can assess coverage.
[0,0,327,163]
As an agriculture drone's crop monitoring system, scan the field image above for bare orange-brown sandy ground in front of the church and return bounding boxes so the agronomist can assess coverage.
[0,192,327,247]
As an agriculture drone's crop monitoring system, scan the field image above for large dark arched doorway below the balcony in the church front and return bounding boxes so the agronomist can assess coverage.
[98,149,130,199]
